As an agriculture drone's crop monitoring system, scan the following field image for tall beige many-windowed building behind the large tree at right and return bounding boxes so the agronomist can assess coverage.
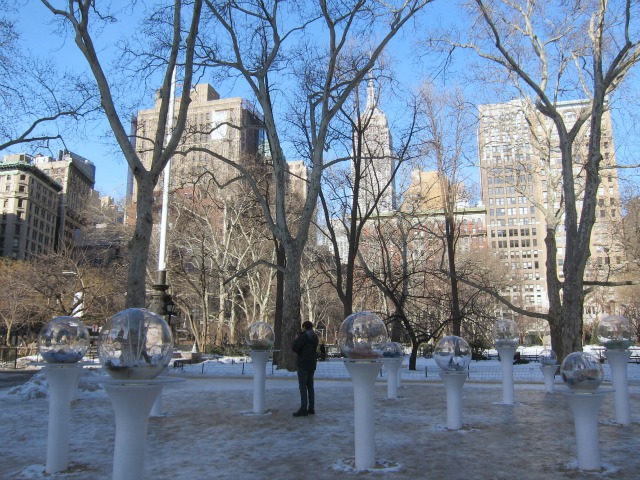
[478,100,624,313]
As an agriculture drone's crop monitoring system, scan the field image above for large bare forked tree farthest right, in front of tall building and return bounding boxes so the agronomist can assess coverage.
[436,0,640,358]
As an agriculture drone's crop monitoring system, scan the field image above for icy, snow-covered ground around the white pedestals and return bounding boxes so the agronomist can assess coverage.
[0,353,640,480]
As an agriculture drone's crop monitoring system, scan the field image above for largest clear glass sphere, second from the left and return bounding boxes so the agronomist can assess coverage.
[98,308,173,380]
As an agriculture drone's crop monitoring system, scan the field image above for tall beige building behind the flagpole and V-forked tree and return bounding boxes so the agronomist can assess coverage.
[127,83,263,206]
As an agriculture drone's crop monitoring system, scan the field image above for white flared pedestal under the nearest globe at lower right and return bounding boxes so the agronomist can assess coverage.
[565,391,609,470]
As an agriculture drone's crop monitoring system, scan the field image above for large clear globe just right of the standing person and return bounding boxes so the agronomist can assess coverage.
[338,312,387,359]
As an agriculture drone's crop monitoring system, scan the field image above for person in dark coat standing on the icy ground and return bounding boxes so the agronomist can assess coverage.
[291,320,319,417]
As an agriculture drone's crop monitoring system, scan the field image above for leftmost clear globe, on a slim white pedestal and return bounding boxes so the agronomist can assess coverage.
[38,317,90,363]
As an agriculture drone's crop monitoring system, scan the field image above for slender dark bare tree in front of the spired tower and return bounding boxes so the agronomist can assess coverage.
[319,73,416,318]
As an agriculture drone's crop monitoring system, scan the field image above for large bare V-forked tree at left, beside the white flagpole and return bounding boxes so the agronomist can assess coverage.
[41,0,202,307]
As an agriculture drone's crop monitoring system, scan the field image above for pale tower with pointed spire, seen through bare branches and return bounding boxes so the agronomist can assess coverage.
[351,75,396,215]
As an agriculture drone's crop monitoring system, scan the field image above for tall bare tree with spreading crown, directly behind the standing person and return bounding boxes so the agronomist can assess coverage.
[201,0,429,369]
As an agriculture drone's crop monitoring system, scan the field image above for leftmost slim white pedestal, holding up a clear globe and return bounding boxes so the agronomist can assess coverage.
[43,363,83,473]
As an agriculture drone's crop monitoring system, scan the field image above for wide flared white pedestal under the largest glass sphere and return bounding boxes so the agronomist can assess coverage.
[104,380,162,480]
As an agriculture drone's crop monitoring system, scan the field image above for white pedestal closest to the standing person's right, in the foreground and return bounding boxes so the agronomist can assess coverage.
[345,360,380,470]
